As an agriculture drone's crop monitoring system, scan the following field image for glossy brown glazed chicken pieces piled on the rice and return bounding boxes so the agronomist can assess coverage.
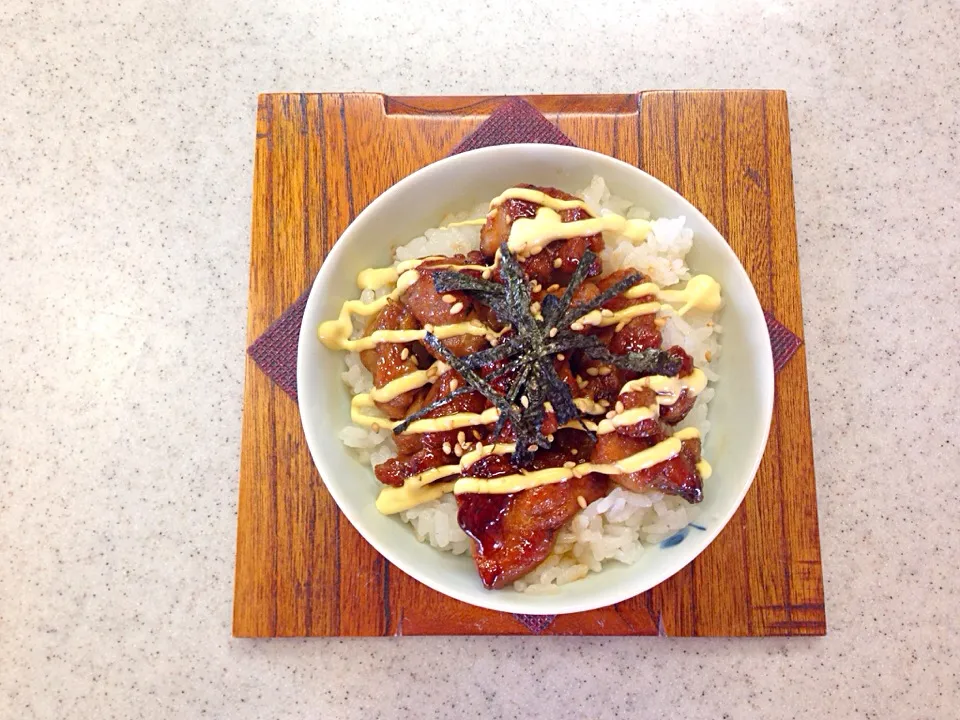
[344,185,703,588]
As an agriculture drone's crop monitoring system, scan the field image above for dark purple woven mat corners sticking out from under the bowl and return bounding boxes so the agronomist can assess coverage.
[247,98,802,634]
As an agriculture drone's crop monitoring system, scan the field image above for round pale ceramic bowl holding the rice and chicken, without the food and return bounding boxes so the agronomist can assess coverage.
[297,145,773,614]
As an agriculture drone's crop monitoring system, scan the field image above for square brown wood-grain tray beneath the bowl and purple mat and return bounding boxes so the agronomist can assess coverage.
[233,91,826,637]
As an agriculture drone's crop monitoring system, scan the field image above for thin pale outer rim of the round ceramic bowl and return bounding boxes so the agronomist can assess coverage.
[297,143,774,615]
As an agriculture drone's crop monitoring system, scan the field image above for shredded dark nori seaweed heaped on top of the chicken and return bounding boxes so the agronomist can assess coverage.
[420,243,680,466]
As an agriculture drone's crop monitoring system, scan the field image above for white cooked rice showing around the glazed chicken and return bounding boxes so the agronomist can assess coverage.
[332,177,722,593]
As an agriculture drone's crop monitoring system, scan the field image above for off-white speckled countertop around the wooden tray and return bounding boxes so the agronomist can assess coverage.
[0,0,960,720]
